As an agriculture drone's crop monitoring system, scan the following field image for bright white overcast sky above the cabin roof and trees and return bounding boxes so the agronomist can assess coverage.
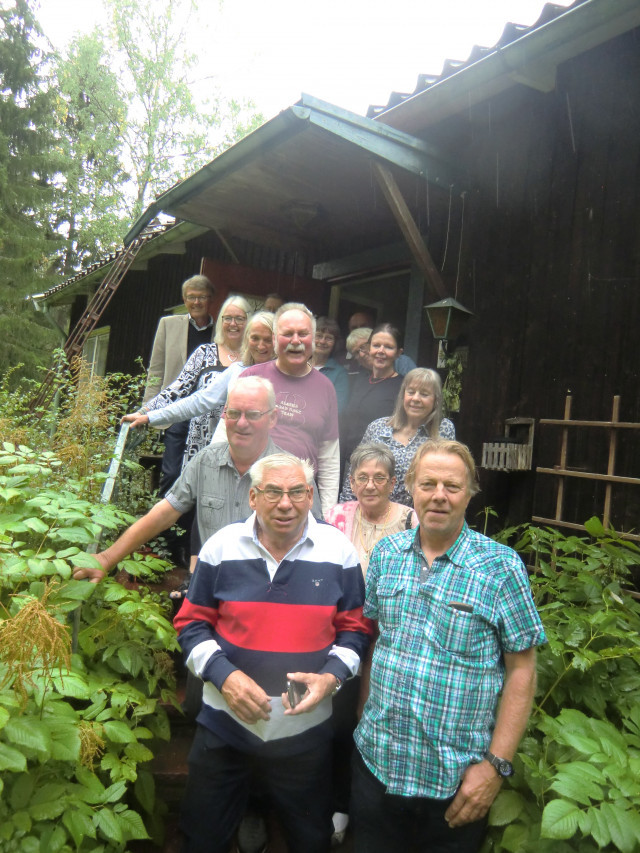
[37,0,571,119]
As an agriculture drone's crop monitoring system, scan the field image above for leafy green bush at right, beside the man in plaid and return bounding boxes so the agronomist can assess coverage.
[484,519,640,853]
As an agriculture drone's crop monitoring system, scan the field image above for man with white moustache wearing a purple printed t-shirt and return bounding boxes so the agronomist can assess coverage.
[243,302,340,514]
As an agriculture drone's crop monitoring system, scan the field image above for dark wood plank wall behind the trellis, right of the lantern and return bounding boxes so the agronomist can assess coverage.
[432,26,640,529]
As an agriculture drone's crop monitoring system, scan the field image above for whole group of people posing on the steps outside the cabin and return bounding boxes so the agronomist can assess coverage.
[75,276,545,853]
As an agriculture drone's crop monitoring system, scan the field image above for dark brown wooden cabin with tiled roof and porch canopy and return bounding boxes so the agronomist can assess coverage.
[32,0,640,533]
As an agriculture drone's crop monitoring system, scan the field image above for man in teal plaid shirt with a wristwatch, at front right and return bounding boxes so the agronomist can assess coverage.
[352,439,545,853]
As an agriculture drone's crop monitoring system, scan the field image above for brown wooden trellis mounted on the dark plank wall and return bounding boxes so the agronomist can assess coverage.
[532,394,640,542]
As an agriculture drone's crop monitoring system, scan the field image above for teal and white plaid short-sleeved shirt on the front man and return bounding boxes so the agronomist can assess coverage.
[355,523,545,799]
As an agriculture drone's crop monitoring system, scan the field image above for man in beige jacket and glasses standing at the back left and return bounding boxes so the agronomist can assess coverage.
[141,275,215,495]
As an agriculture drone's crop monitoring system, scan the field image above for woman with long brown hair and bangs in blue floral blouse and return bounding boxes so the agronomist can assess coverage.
[340,367,456,506]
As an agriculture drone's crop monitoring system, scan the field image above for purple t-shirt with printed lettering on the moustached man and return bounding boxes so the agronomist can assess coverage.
[242,361,338,471]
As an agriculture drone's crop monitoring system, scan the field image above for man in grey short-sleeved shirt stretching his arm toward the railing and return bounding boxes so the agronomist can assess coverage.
[74,376,279,582]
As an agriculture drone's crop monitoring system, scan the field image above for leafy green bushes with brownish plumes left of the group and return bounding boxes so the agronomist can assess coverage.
[0,364,177,853]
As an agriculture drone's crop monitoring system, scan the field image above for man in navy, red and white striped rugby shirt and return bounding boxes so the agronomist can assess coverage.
[175,454,376,853]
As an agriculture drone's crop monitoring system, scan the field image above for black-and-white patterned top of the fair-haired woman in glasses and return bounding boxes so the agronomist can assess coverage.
[145,344,225,470]
